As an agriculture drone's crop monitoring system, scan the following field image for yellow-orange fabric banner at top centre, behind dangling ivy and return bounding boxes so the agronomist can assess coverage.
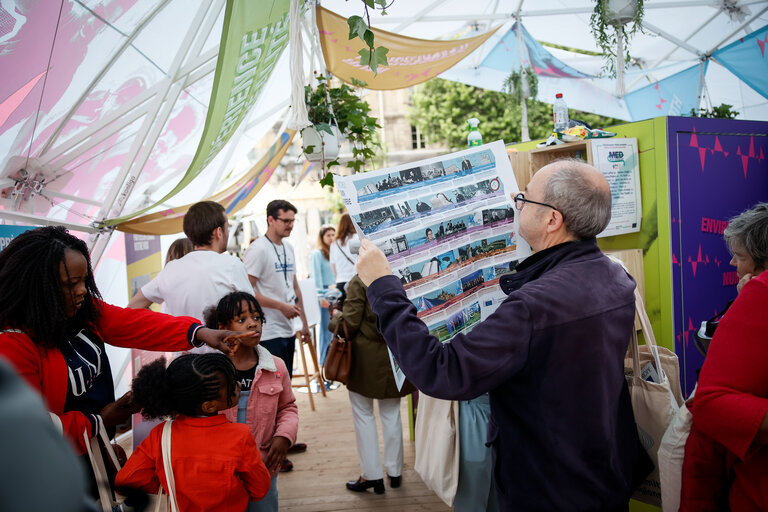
[317,7,498,91]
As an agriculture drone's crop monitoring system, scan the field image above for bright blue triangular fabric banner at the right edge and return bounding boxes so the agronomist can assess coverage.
[713,25,768,98]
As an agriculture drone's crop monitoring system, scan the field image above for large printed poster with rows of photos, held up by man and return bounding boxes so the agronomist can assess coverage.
[335,141,530,386]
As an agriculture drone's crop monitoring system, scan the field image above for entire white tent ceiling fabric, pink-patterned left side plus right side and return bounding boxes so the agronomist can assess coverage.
[0,0,768,243]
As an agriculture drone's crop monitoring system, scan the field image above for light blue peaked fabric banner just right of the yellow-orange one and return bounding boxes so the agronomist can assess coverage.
[481,23,590,78]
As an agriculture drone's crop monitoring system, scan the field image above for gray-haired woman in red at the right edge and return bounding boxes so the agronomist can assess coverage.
[680,203,768,512]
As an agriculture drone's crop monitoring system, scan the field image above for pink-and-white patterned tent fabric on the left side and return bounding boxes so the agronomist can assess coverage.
[0,0,289,240]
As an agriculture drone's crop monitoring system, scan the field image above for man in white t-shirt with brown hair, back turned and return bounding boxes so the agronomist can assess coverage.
[128,201,253,328]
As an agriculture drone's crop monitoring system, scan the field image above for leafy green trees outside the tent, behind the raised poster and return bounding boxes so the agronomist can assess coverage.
[408,78,623,151]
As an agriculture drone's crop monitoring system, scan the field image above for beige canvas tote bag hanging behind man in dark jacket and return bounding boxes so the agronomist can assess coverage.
[624,289,682,506]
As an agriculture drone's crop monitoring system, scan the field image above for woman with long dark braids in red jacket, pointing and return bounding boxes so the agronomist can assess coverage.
[0,226,235,454]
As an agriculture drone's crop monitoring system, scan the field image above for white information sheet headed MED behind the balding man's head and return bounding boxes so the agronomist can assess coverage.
[591,138,643,237]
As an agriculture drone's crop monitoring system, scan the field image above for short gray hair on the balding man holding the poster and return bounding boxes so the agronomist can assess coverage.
[544,159,611,240]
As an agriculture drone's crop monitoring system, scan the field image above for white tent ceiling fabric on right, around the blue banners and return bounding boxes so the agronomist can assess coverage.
[322,0,768,120]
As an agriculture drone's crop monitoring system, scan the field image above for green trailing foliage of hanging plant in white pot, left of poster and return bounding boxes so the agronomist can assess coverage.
[304,75,381,183]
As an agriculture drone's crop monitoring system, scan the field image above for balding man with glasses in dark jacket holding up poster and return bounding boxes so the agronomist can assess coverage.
[357,161,644,512]
